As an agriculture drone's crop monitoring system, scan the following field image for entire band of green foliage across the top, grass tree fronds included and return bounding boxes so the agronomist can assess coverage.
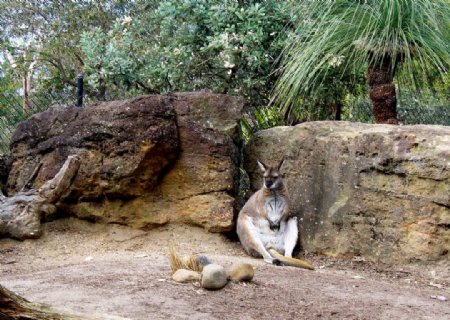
[0,0,450,142]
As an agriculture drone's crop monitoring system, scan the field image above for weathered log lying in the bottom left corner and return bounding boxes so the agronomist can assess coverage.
[0,285,125,320]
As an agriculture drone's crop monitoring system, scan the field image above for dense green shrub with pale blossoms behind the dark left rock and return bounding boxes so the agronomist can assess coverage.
[81,0,293,106]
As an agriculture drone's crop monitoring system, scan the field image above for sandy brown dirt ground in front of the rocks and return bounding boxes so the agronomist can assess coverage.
[0,219,450,320]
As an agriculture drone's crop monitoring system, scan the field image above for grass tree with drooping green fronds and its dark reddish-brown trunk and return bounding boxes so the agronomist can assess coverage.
[275,0,450,124]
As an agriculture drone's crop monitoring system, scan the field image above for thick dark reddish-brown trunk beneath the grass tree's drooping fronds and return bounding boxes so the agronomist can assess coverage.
[367,55,398,124]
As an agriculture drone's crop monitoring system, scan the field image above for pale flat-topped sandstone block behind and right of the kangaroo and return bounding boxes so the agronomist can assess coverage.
[244,122,450,264]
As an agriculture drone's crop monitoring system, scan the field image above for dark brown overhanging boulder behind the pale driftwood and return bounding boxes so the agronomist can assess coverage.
[8,96,179,198]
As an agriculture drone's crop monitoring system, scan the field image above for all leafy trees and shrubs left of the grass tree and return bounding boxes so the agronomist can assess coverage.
[0,0,296,106]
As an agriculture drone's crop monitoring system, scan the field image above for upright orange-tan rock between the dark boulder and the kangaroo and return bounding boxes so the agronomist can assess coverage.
[149,93,243,232]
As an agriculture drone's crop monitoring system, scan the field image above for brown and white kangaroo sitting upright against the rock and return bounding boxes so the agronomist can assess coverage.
[236,160,314,269]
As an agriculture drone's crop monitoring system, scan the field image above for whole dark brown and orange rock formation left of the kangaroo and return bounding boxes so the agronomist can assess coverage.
[7,93,243,232]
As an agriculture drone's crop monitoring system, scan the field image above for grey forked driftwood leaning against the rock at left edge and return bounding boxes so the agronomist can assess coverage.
[0,155,80,240]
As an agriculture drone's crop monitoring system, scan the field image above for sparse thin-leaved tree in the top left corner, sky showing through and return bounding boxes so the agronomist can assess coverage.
[0,0,134,98]
